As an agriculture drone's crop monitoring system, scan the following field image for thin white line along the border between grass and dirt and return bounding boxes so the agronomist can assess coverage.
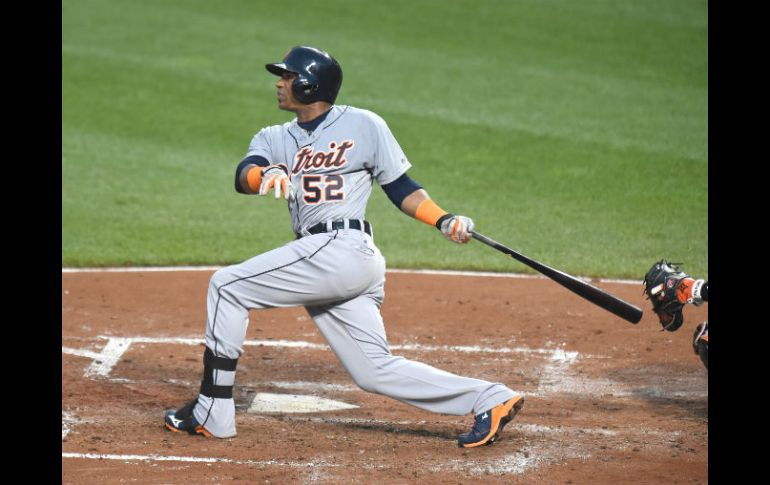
[61,266,642,285]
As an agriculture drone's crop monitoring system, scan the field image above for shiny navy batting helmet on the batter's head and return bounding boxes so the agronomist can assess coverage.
[265,46,342,104]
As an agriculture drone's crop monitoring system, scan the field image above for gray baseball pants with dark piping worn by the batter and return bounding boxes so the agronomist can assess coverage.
[193,229,518,438]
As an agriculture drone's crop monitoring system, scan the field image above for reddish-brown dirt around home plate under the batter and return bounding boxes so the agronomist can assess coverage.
[62,271,708,484]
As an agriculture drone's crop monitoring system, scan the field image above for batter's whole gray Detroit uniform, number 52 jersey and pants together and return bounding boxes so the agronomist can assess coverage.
[193,106,518,438]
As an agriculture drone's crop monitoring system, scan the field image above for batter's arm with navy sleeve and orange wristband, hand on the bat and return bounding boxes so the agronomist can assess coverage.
[382,173,473,244]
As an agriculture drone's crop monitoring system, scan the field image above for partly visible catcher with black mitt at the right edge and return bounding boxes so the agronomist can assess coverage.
[643,259,709,370]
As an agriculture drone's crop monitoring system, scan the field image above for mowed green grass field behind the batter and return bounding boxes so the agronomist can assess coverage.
[62,0,708,278]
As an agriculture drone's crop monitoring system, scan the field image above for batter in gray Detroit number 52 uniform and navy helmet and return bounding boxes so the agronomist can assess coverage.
[164,46,524,447]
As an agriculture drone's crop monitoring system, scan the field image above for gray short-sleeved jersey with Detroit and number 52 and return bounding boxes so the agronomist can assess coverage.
[246,106,412,234]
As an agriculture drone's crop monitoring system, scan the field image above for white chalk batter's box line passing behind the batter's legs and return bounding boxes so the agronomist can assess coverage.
[61,335,579,378]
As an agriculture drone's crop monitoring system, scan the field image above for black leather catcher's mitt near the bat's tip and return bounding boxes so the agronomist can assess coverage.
[644,259,692,332]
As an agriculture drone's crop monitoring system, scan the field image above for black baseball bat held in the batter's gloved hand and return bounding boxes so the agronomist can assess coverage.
[471,232,642,324]
